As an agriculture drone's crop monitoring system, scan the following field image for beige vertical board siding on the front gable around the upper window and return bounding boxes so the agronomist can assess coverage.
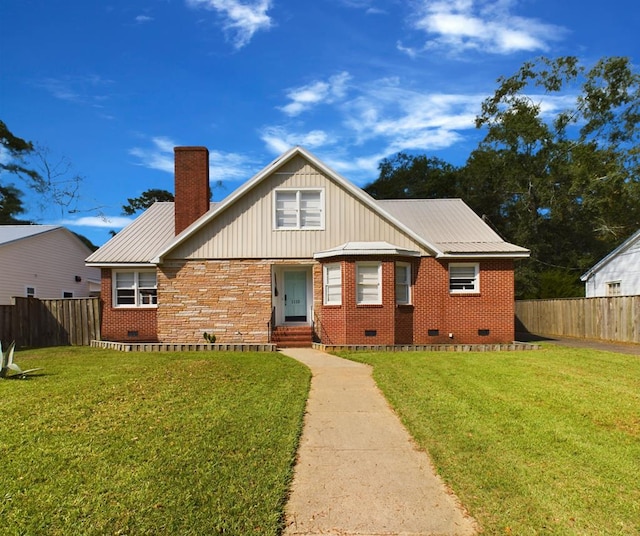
[168,156,429,259]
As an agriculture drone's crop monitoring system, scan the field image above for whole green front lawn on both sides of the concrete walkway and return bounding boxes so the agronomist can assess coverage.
[0,347,640,536]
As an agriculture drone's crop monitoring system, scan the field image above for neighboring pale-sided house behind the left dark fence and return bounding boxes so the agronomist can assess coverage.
[0,225,100,305]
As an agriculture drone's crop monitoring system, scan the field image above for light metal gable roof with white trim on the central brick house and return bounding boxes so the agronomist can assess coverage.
[87,147,529,266]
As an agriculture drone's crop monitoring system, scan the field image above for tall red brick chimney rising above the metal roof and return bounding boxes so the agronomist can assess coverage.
[174,147,210,234]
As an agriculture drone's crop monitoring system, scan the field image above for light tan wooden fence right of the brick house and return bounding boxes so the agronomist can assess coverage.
[516,296,640,343]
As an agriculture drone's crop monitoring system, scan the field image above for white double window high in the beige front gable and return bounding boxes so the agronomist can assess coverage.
[274,189,324,230]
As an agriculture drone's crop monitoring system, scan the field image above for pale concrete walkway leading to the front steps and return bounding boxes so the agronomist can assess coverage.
[282,348,477,536]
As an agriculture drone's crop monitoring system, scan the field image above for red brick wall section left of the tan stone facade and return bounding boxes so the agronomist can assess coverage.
[100,268,158,342]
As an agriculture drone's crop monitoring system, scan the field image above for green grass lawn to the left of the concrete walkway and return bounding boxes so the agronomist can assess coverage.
[0,347,310,536]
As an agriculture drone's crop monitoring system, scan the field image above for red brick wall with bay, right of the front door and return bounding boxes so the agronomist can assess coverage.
[316,257,515,344]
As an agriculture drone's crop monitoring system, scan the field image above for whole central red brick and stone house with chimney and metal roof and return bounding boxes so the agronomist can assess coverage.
[87,147,529,345]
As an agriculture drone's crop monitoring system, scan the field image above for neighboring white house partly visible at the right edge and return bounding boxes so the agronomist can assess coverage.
[580,231,640,298]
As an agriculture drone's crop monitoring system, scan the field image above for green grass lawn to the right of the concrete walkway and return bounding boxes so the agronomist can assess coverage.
[341,347,640,536]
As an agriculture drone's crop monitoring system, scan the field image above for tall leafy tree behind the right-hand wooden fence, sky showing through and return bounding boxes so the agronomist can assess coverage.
[465,57,640,297]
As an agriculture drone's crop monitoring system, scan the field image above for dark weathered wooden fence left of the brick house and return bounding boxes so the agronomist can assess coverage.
[0,298,100,348]
